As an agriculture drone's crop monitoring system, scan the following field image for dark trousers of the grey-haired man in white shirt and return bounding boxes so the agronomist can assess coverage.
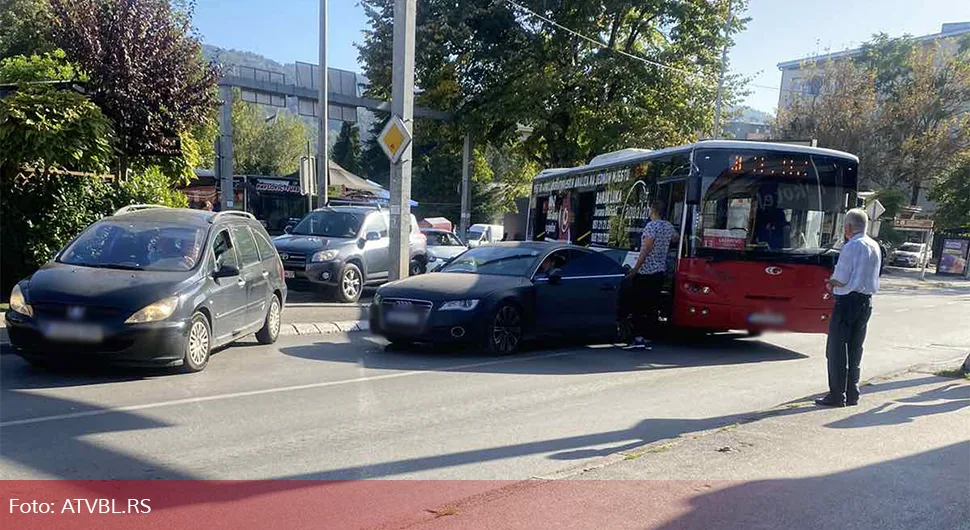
[825,292,872,401]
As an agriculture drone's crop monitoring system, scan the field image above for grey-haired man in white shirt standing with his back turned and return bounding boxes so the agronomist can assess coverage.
[815,208,882,407]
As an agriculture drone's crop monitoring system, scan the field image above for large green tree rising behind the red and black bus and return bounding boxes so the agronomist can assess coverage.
[359,0,746,219]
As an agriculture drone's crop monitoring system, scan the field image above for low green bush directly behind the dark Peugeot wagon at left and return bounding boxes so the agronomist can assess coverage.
[0,169,188,294]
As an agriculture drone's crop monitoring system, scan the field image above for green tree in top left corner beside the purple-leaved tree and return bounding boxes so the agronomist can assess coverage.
[0,0,54,58]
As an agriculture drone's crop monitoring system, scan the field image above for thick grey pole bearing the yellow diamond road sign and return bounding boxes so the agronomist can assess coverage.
[388,0,417,281]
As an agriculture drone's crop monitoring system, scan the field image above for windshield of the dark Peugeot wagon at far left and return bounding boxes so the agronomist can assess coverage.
[57,221,206,271]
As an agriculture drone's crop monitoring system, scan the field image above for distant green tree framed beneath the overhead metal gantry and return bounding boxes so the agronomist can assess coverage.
[232,94,308,175]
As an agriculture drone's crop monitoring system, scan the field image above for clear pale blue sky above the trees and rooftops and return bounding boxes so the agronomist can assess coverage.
[195,0,970,111]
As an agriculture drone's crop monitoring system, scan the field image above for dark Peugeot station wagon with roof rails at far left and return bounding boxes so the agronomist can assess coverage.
[6,206,286,372]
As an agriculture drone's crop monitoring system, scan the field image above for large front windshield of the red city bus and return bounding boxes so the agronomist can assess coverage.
[691,149,856,257]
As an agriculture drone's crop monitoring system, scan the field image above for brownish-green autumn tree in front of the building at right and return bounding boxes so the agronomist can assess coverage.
[779,35,970,205]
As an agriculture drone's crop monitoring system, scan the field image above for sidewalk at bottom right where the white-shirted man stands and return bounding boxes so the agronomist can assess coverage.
[395,362,970,530]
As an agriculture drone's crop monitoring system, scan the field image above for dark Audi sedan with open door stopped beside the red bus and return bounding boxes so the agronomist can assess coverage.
[370,242,623,354]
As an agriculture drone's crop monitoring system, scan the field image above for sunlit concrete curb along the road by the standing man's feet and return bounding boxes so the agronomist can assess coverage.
[530,355,963,481]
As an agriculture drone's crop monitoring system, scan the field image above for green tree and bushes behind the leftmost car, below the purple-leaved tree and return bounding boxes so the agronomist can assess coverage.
[0,52,186,297]
